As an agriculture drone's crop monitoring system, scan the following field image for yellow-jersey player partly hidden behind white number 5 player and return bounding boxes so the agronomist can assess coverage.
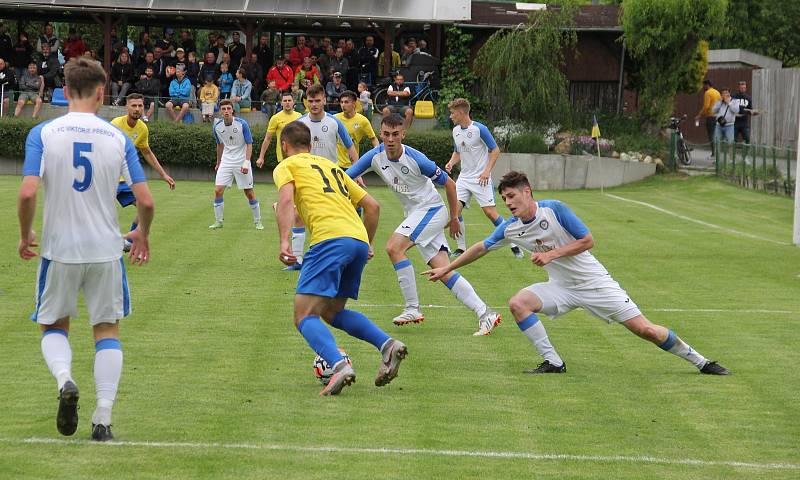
[111,93,175,252]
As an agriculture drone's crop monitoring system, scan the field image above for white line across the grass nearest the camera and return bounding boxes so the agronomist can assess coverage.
[0,437,800,470]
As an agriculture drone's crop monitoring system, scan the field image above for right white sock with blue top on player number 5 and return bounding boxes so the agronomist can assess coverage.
[92,338,122,426]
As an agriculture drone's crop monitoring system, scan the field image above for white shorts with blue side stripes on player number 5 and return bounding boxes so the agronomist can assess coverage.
[31,258,131,325]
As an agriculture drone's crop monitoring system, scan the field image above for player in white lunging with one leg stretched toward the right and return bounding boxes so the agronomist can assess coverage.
[423,172,730,375]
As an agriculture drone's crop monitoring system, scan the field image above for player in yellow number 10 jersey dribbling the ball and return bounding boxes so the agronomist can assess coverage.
[273,122,407,395]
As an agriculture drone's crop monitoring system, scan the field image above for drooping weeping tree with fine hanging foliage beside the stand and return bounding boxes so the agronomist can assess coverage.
[475,2,577,122]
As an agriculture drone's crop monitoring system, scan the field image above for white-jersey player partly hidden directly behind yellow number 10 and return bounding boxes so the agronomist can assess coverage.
[284,84,358,270]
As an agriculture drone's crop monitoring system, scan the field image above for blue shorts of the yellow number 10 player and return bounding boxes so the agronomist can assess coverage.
[295,237,369,300]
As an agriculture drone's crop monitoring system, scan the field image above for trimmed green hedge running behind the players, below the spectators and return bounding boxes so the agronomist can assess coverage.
[0,118,453,168]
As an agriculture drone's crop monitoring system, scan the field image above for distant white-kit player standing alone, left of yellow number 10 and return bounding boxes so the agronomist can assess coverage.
[208,100,264,230]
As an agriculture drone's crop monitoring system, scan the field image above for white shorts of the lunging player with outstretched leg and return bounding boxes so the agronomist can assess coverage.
[525,277,642,323]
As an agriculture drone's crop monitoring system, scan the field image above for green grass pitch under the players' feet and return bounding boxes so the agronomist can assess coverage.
[0,173,800,479]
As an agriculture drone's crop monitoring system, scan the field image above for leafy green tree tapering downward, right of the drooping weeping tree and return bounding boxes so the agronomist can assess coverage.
[622,0,728,134]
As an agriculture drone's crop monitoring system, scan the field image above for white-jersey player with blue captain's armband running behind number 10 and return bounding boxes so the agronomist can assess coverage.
[347,113,500,336]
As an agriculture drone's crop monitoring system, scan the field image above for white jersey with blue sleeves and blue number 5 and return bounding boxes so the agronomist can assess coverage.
[22,113,145,263]
